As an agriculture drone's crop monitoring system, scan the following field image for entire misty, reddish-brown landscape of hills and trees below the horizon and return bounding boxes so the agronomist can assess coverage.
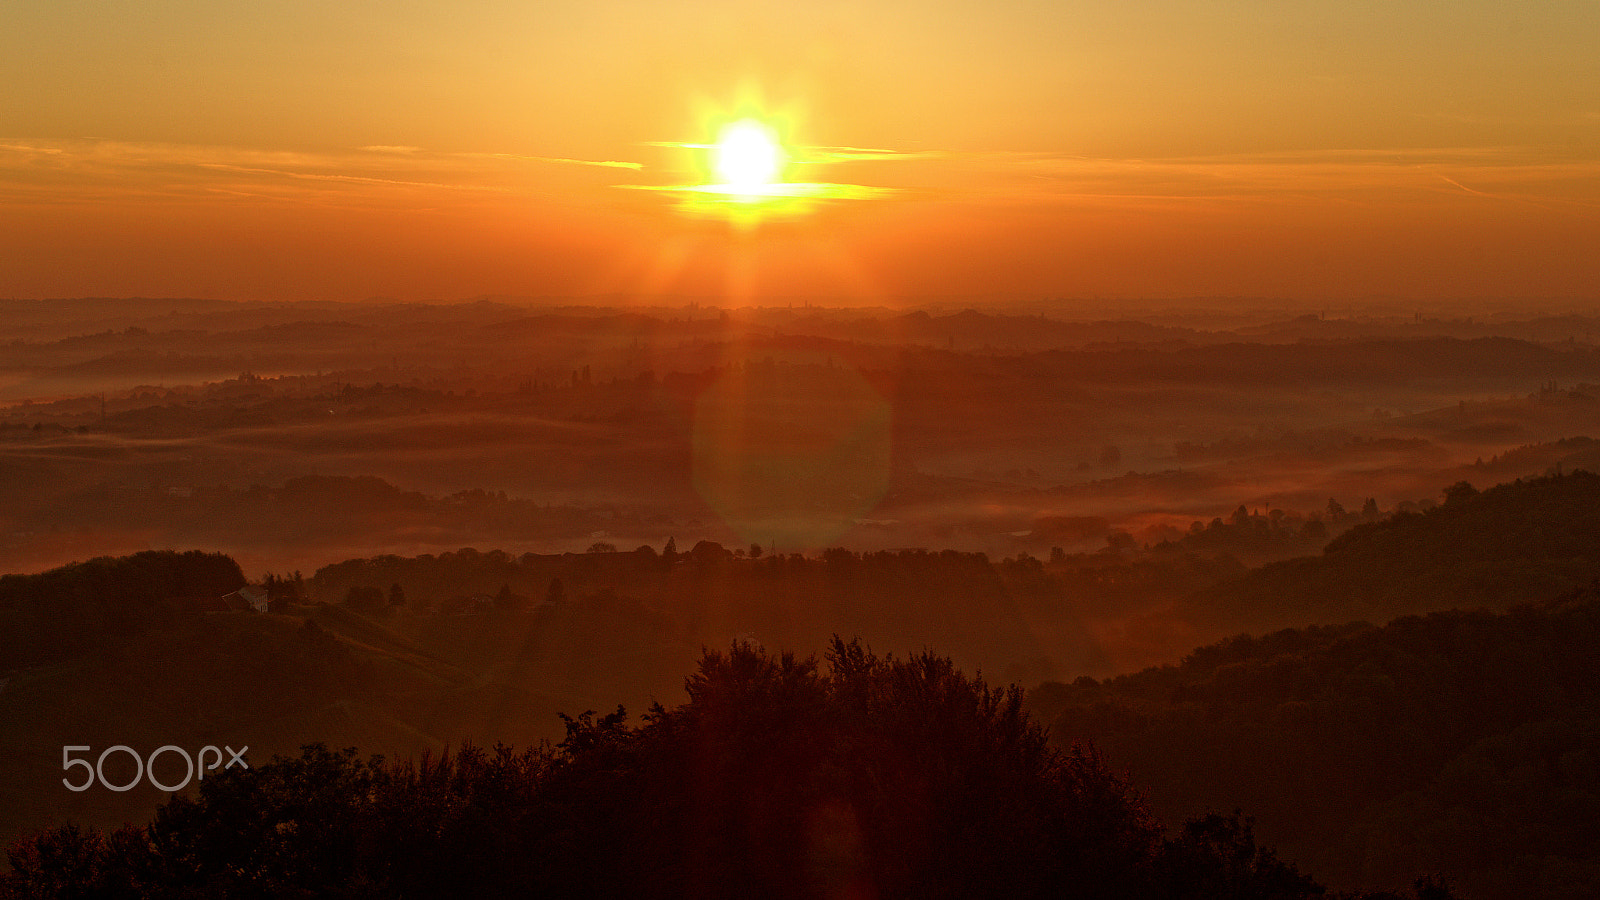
[0,298,1600,900]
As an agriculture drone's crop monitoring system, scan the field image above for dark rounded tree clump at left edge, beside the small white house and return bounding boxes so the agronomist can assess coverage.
[0,549,245,669]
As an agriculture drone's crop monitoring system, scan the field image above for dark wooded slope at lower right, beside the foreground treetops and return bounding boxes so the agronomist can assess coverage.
[1030,583,1600,900]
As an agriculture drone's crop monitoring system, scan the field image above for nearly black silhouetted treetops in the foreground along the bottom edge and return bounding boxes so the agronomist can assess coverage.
[0,639,1450,900]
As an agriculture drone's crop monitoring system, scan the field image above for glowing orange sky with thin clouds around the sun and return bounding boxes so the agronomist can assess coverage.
[0,0,1600,304]
